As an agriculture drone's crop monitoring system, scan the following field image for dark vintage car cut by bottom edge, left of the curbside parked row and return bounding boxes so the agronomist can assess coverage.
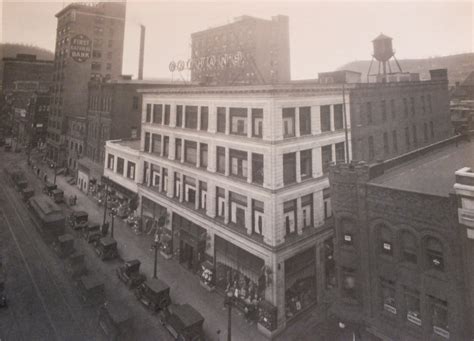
[98,302,135,341]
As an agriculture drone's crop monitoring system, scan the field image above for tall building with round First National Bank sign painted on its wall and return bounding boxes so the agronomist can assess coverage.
[47,2,126,166]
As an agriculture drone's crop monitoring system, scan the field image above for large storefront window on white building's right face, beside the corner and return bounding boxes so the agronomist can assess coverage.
[285,247,316,319]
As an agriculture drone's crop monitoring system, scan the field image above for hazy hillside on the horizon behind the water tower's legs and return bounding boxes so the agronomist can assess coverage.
[339,53,474,85]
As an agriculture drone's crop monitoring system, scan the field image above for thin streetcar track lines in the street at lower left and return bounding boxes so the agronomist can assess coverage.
[2,177,85,339]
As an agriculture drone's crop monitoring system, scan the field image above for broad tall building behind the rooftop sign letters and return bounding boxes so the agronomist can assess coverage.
[191,15,291,85]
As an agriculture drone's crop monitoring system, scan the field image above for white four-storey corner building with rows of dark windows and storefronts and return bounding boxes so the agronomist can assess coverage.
[104,84,345,333]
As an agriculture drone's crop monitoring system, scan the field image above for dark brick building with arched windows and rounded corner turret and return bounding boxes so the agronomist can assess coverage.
[329,138,474,340]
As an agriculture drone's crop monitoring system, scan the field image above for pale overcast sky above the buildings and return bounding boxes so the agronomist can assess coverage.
[0,0,474,79]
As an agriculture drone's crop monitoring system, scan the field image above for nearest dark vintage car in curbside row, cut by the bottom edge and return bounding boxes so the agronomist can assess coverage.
[159,304,205,341]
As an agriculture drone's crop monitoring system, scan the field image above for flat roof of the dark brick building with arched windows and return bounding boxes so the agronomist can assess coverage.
[369,138,474,197]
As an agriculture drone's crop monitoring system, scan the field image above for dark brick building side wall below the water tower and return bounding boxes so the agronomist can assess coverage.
[350,70,453,163]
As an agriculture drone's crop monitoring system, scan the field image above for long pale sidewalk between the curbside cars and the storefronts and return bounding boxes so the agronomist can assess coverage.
[48,169,266,341]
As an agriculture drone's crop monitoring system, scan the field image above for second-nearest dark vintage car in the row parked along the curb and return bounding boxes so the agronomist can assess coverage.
[135,278,171,311]
